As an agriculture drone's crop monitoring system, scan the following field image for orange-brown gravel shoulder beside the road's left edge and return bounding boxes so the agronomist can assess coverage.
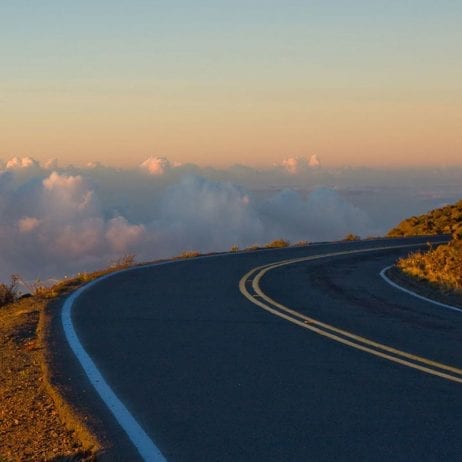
[0,297,100,462]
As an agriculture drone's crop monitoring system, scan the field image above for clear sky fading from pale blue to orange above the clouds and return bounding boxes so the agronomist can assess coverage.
[0,0,462,167]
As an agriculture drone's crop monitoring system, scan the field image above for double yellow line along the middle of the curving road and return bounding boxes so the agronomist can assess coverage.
[239,244,462,383]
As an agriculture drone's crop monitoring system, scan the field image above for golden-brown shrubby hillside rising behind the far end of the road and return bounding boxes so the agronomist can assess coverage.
[387,200,462,239]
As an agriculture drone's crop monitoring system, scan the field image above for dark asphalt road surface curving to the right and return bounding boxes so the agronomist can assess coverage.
[53,239,462,462]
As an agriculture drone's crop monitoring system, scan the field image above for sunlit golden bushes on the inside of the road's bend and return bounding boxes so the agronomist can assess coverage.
[397,239,462,292]
